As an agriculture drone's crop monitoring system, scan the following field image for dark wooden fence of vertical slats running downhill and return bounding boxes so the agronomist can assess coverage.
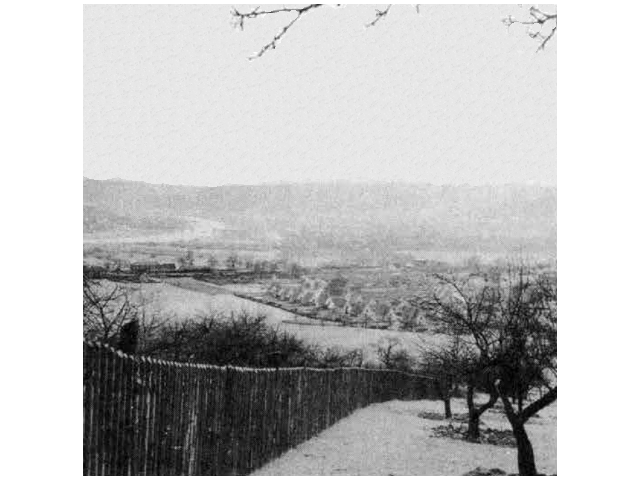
[83,342,437,475]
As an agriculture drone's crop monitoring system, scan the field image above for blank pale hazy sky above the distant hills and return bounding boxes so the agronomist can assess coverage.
[84,5,557,186]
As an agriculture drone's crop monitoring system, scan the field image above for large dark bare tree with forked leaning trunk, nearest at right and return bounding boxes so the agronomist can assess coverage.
[434,265,558,475]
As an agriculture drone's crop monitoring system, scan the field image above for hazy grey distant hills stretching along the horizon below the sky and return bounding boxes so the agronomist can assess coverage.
[83,178,557,255]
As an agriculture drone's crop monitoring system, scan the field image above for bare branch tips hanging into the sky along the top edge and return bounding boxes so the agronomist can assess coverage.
[231,3,557,60]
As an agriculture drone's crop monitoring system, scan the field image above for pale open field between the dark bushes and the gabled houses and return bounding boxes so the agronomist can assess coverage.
[112,278,445,361]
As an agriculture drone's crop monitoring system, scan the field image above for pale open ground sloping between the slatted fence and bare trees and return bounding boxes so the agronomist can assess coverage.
[253,400,557,476]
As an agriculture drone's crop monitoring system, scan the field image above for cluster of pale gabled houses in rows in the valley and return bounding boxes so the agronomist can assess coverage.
[267,278,428,330]
